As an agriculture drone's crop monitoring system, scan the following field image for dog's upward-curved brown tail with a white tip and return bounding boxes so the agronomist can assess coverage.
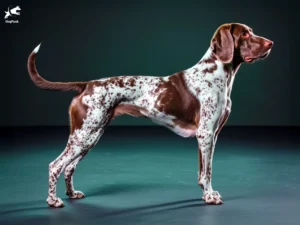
[27,44,88,93]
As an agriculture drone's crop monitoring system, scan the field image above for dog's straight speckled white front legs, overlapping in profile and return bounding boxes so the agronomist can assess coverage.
[196,95,223,204]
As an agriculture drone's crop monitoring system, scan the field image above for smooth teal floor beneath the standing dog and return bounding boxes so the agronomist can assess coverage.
[0,126,300,225]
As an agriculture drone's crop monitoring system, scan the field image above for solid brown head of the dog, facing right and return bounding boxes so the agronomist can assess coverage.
[211,23,273,63]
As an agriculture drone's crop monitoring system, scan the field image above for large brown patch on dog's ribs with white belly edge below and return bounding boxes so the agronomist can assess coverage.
[147,72,200,137]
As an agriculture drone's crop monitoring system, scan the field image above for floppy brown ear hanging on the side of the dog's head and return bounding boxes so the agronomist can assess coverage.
[211,24,234,63]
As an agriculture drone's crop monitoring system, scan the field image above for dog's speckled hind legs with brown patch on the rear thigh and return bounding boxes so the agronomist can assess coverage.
[47,92,111,207]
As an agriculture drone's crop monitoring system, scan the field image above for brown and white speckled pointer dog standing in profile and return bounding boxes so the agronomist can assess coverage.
[28,23,273,207]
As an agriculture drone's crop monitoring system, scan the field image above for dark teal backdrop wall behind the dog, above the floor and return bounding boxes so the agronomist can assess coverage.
[0,0,300,126]
